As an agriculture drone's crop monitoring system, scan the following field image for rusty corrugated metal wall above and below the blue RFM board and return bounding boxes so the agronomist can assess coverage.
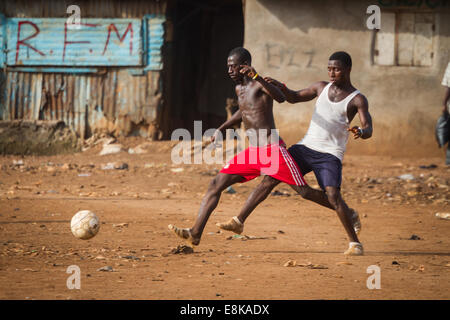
[0,0,166,138]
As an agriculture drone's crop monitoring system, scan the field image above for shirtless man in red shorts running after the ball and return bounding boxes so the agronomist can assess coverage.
[169,47,330,245]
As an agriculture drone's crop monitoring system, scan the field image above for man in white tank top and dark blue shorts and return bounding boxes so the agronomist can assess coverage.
[217,52,372,255]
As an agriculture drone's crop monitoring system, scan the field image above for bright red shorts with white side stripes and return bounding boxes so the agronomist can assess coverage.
[220,144,306,186]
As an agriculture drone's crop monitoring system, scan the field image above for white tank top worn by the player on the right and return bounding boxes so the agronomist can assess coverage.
[297,82,359,162]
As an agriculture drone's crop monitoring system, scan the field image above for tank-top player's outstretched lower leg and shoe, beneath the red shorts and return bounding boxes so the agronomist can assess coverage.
[216,176,281,234]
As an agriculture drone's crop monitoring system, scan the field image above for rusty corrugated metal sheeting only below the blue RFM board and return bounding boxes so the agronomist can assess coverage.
[0,69,162,138]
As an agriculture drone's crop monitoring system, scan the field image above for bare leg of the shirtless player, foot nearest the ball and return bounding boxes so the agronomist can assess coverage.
[169,173,243,245]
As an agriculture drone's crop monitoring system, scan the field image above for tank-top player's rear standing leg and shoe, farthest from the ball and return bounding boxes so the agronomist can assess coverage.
[325,186,363,255]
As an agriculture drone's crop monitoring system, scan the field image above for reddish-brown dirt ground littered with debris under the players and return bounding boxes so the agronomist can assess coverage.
[0,138,450,300]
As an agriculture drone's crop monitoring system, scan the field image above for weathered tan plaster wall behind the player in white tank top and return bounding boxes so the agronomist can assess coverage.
[244,0,450,156]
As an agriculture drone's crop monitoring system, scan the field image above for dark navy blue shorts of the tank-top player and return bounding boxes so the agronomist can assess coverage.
[288,144,342,190]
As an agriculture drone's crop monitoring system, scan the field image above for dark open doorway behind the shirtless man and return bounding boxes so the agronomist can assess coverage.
[164,0,244,139]
